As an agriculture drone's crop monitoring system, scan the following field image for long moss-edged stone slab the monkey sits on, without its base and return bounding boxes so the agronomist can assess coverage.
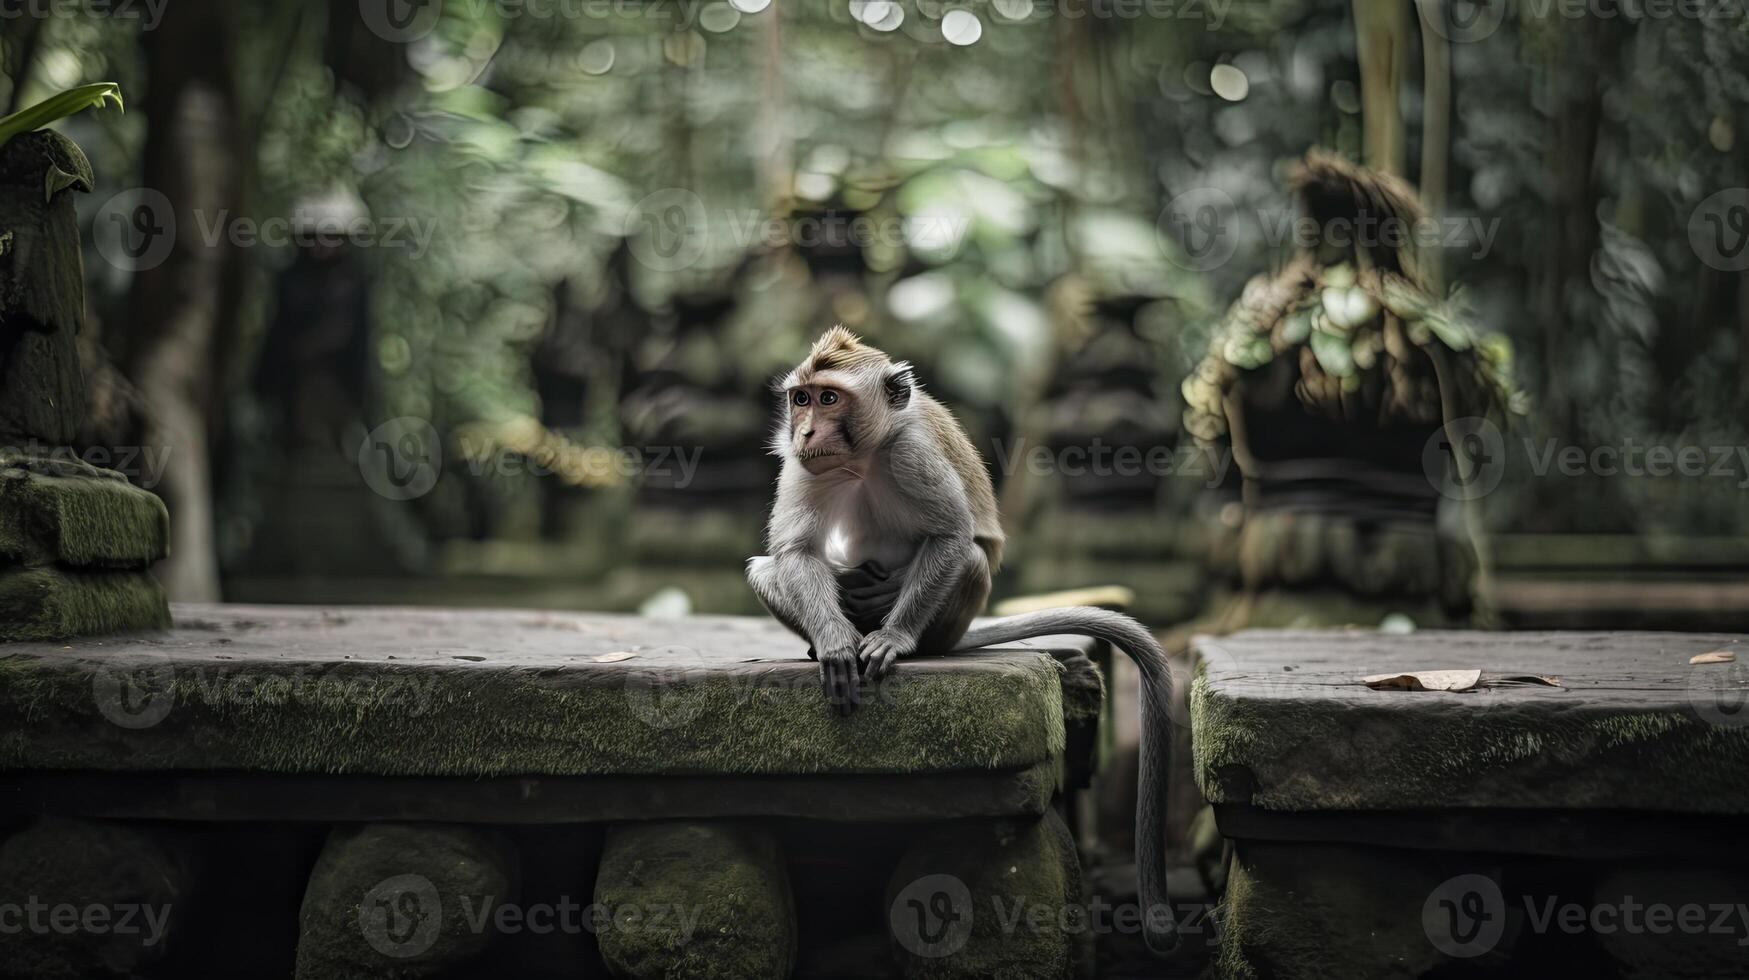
[0,606,1063,775]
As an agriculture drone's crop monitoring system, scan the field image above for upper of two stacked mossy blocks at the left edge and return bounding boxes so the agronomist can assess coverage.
[0,459,170,569]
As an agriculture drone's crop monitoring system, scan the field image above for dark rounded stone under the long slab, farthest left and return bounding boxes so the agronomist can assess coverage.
[0,817,194,980]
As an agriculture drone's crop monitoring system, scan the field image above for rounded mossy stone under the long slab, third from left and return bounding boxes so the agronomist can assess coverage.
[595,821,796,980]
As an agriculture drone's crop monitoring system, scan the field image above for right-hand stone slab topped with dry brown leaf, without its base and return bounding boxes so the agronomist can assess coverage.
[1191,630,1749,814]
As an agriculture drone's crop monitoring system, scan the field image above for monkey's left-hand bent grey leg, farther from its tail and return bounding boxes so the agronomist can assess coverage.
[747,551,862,714]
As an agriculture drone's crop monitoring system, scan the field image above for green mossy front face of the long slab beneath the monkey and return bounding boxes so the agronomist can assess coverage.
[0,644,1063,775]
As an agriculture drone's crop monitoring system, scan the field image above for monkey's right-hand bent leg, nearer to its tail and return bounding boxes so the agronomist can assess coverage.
[861,537,990,679]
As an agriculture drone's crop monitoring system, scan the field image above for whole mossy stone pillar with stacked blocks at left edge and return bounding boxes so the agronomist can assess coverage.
[0,131,170,641]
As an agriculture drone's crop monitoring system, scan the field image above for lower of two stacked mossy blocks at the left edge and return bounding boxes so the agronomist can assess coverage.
[0,567,170,641]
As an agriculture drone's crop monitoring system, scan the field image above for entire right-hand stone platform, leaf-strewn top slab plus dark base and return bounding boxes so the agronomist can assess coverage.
[1191,630,1749,978]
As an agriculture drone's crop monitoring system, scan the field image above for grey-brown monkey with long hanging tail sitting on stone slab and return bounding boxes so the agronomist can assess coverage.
[747,326,1177,954]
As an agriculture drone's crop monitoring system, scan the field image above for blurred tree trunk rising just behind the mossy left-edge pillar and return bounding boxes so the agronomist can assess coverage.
[114,0,240,602]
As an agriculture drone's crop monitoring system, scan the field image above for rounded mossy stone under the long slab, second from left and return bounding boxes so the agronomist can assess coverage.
[286,824,519,980]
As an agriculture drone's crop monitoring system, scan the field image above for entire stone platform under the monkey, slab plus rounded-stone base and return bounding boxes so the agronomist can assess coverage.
[0,606,1104,980]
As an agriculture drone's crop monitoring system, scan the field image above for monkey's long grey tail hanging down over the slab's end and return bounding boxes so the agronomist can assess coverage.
[953,606,1177,954]
